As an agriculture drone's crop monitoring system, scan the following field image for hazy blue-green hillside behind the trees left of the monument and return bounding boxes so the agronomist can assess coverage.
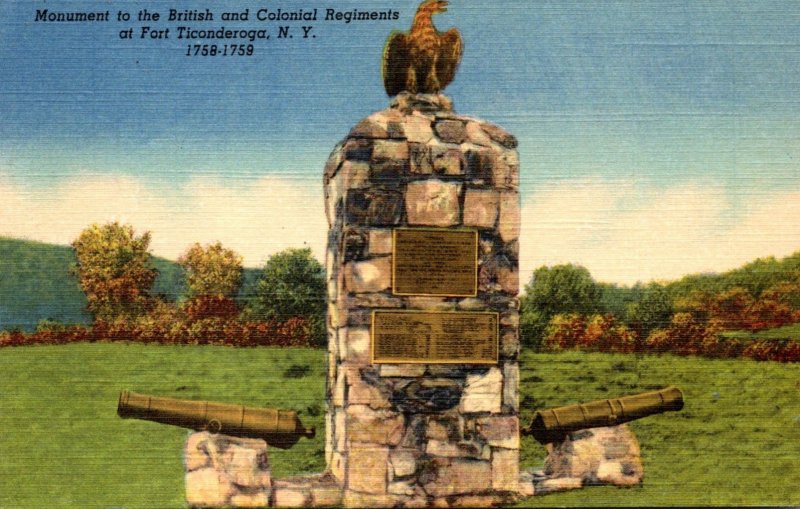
[0,237,258,331]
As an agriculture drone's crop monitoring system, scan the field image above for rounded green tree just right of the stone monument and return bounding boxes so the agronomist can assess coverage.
[520,264,602,349]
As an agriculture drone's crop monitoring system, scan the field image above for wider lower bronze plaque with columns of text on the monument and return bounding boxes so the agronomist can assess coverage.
[372,311,499,364]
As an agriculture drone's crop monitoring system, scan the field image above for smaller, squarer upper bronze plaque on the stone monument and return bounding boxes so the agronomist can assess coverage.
[392,228,478,297]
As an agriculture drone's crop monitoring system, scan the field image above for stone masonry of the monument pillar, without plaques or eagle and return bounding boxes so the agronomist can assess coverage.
[324,94,520,506]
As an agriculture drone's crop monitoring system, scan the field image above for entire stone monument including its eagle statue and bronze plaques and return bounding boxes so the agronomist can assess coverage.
[324,1,520,507]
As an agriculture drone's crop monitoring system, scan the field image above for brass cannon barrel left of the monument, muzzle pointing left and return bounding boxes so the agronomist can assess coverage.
[117,391,315,449]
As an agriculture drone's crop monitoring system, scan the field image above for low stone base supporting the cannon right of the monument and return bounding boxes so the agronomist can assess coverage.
[520,424,644,496]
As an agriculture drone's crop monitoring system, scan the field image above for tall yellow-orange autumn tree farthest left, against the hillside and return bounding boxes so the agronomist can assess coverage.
[72,222,158,321]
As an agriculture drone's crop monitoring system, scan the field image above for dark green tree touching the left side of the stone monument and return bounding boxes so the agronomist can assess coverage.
[247,248,326,345]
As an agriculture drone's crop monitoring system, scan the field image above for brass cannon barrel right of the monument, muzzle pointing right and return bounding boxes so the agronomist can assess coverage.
[523,386,683,444]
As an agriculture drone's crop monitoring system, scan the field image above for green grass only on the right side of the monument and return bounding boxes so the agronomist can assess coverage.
[520,353,800,507]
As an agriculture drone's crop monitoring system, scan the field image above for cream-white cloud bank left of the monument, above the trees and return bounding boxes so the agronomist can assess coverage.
[0,176,327,266]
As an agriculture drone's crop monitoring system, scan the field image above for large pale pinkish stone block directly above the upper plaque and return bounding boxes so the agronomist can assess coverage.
[406,180,461,227]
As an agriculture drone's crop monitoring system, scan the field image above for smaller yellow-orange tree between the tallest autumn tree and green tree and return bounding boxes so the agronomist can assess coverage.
[178,242,244,319]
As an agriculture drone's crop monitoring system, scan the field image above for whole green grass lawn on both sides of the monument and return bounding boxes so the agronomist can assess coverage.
[0,344,800,509]
